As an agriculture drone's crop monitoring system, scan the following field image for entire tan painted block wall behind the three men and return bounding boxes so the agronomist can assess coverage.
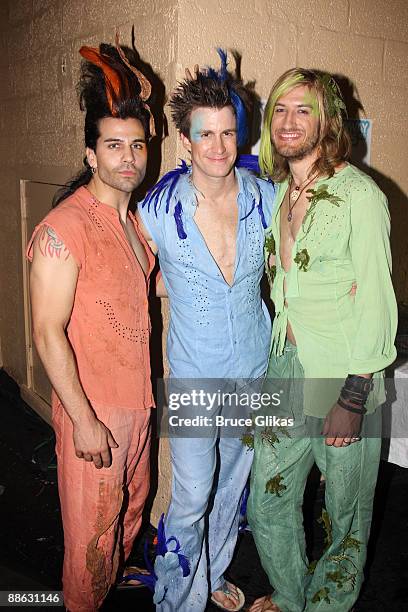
[0,0,408,517]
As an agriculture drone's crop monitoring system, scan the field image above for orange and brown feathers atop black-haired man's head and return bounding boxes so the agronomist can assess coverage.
[79,33,156,136]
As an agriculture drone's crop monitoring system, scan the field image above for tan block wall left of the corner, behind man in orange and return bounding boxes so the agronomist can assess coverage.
[0,0,178,383]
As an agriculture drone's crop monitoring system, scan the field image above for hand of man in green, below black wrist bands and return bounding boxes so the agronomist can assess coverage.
[322,403,364,447]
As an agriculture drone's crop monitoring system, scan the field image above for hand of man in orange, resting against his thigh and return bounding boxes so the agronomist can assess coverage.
[73,417,119,469]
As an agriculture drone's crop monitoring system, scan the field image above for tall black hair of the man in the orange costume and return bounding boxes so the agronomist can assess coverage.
[52,43,150,208]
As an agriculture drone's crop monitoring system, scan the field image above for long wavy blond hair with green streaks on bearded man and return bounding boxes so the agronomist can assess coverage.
[259,68,351,182]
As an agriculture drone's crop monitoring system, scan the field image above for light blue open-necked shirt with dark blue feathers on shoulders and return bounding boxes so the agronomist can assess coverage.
[139,168,275,379]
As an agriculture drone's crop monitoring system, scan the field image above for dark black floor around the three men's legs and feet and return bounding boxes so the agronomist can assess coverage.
[0,370,408,612]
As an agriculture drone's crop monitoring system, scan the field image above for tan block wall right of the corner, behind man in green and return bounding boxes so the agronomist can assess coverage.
[177,0,408,302]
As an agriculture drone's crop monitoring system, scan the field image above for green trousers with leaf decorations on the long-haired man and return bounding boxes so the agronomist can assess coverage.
[248,345,381,612]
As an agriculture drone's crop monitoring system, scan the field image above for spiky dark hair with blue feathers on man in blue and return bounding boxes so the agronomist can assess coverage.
[169,49,251,146]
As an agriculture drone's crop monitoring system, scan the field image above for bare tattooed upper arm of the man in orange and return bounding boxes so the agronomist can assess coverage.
[30,226,79,328]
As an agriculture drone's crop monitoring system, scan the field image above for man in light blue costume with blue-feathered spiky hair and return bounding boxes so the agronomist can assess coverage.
[139,51,275,612]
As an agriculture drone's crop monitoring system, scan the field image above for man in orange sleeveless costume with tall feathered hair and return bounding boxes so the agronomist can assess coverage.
[27,43,159,612]
